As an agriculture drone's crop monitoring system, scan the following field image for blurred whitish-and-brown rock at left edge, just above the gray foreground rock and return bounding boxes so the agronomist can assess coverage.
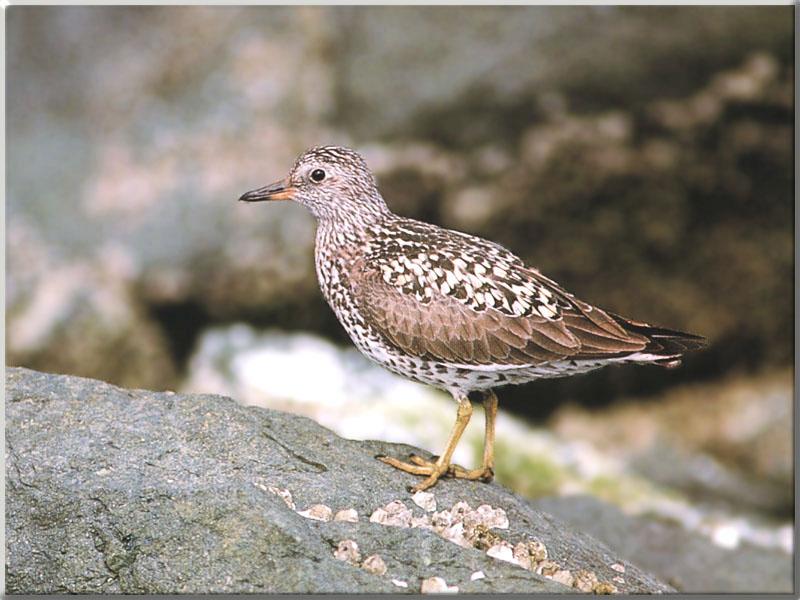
[6,219,177,388]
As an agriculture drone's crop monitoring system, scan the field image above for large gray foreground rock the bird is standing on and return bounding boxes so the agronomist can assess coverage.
[6,368,672,594]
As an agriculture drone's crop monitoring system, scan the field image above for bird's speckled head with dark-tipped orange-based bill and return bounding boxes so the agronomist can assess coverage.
[239,146,388,221]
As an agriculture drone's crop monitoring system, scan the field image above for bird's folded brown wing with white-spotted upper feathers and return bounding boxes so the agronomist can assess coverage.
[351,224,647,367]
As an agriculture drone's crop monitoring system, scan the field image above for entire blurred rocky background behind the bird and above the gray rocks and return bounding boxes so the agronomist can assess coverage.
[6,6,794,580]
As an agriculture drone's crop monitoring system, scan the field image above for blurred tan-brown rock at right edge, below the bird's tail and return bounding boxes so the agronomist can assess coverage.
[553,371,794,515]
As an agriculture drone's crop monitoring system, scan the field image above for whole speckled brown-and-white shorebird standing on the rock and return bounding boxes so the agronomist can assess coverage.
[239,145,706,493]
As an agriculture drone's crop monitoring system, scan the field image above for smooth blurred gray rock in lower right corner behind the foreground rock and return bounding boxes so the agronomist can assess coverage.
[533,496,793,593]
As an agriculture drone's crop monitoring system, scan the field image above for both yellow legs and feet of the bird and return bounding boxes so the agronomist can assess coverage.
[377,390,497,492]
